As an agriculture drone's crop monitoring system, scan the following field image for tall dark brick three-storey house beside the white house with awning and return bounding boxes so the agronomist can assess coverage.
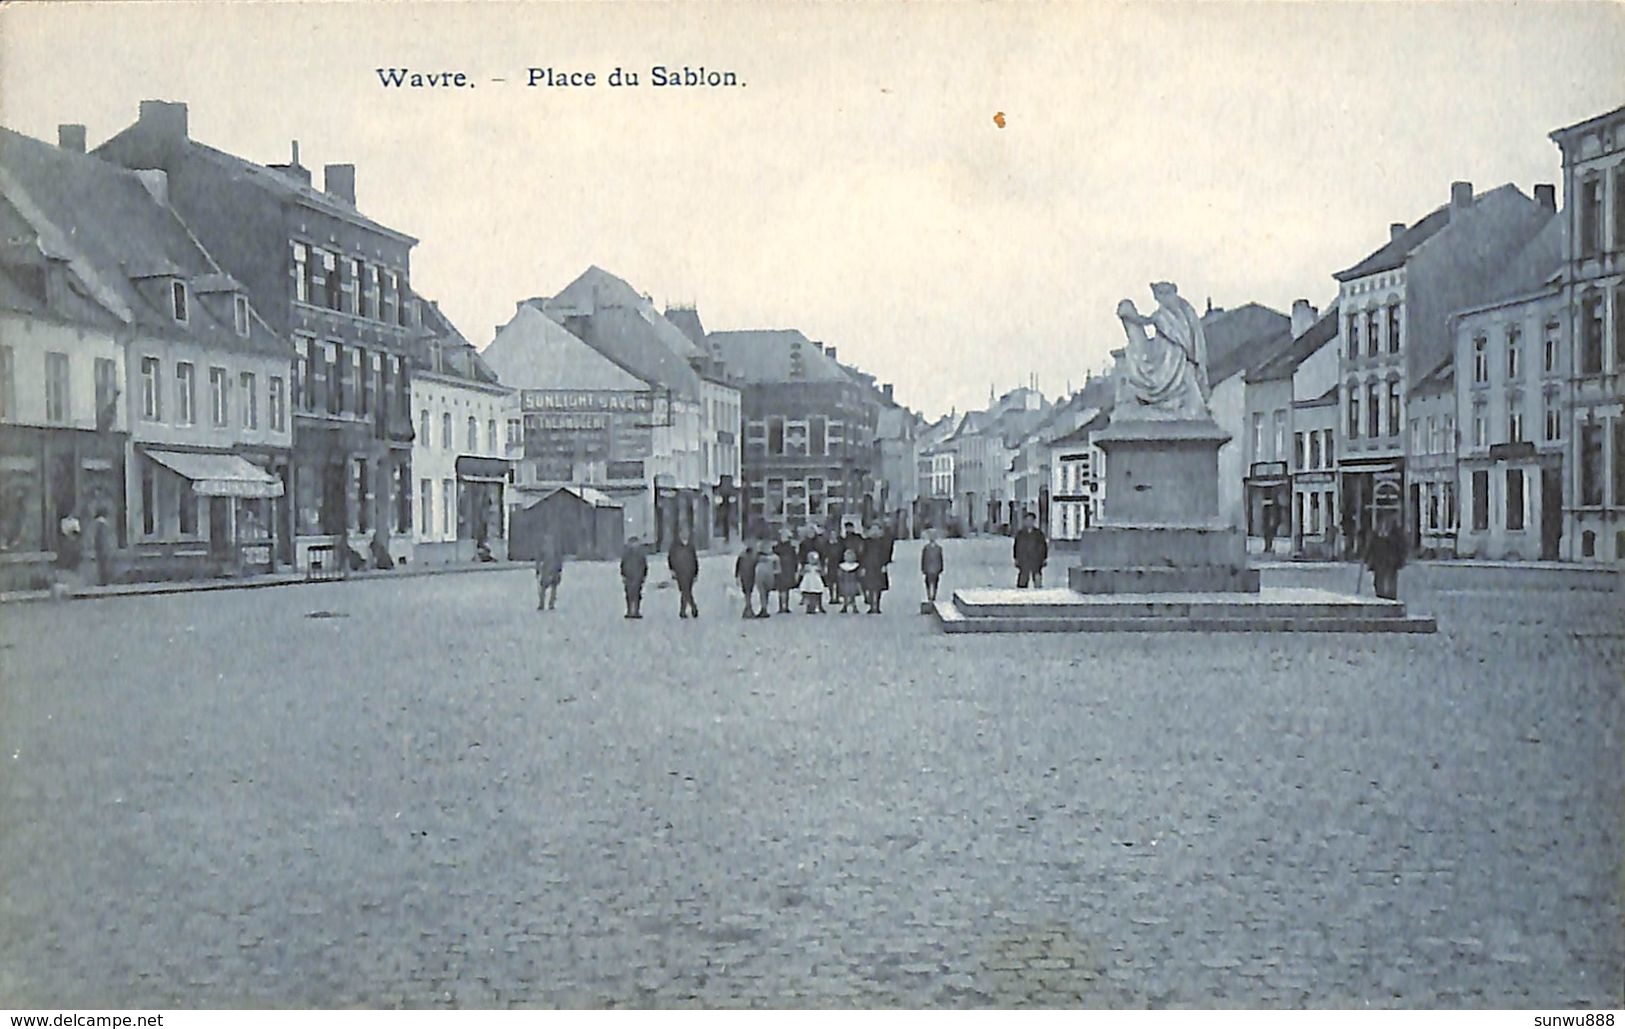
[94,101,421,567]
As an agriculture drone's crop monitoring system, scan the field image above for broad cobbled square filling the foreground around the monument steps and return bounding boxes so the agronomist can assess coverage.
[0,540,1625,1009]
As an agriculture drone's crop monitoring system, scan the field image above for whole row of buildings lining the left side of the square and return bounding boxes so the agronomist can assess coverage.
[0,101,918,588]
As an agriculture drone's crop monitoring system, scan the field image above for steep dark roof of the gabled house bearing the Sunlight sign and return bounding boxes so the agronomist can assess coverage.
[530,265,704,400]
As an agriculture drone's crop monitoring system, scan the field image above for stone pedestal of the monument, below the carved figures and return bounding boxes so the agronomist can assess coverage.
[1068,418,1258,593]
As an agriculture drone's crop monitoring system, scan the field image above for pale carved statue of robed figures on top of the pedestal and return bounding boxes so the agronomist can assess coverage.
[1113,283,1211,419]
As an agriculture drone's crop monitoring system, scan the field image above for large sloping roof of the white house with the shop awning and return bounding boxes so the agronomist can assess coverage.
[0,128,293,356]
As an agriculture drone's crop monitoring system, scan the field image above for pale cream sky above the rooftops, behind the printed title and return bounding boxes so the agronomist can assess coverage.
[0,0,1625,415]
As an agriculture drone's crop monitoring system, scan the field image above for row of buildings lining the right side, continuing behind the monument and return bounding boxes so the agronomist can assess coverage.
[918,100,1625,561]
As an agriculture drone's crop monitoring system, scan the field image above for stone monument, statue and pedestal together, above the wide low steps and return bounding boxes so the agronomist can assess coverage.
[1068,283,1258,593]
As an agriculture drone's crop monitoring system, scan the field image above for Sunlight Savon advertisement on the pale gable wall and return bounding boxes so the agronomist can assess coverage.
[520,390,660,464]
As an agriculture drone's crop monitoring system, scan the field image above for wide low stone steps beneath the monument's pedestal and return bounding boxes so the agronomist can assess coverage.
[936,588,1438,632]
